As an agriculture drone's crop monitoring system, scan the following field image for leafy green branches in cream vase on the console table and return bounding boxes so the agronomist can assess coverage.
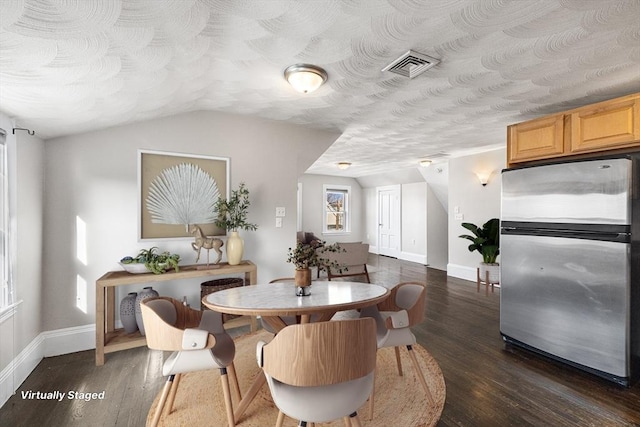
[214,182,258,265]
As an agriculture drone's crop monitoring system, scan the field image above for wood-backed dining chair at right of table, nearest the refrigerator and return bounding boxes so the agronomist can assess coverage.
[360,282,434,418]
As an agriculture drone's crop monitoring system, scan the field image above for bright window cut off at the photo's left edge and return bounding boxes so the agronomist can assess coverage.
[0,129,13,310]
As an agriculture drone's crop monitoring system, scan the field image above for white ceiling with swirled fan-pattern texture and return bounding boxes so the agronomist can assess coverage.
[0,0,640,177]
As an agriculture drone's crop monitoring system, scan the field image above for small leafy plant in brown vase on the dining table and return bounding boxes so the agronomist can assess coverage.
[287,241,345,296]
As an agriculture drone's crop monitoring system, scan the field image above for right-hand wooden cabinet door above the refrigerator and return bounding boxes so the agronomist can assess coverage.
[569,96,640,153]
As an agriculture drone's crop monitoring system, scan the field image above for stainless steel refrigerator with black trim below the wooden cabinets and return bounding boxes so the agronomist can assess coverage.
[500,156,640,385]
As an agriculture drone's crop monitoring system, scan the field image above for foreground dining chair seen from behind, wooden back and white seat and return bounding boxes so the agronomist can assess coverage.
[256,318,376,427]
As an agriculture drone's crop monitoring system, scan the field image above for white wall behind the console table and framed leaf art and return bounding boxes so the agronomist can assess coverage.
[43,112,338,330]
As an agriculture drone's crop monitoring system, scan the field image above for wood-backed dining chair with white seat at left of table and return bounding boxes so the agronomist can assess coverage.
[140,297,241,427]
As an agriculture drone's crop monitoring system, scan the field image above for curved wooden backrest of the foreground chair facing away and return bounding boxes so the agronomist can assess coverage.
[262,318,377,387]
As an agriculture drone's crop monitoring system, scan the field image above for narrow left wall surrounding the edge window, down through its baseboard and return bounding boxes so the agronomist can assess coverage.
[0,114,44,405]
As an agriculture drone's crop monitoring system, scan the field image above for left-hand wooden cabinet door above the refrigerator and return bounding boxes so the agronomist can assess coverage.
[507,114,564,163]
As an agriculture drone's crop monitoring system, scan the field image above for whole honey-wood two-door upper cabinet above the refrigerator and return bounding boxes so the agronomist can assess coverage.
[507,93,640,166]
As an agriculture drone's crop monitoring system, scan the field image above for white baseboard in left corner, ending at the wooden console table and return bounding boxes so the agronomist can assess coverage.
[0,325,96,407]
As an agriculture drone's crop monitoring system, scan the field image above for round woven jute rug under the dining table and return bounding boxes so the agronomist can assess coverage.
[147,331,446,427]
